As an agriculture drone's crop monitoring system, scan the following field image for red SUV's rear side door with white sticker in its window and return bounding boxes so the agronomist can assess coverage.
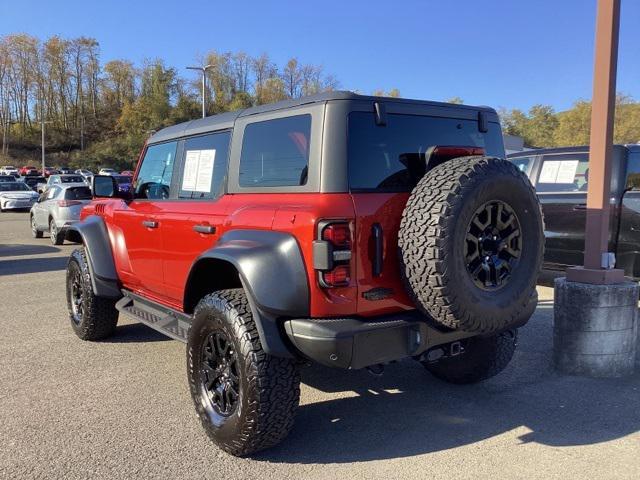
[156,130,231,307]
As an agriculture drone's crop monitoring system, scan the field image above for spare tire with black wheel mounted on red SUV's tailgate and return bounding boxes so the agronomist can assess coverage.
[398,156,544,333]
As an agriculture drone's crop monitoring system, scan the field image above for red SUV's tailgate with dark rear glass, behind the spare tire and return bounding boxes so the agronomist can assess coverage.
[348,106,505,315]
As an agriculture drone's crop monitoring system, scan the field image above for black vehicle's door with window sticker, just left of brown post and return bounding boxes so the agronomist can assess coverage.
[535,152,589,270]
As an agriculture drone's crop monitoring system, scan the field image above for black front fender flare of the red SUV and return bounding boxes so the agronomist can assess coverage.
[65,215,122,298]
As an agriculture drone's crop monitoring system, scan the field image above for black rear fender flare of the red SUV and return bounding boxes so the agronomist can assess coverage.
[185,229,310,357]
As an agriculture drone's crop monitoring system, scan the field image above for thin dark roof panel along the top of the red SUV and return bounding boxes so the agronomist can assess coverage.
[147,90,495,144]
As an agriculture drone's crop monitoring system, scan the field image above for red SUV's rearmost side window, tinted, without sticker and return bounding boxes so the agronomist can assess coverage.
[240,115,311,187]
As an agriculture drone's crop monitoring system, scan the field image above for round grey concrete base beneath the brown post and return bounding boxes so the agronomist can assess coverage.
[553,278,640,377]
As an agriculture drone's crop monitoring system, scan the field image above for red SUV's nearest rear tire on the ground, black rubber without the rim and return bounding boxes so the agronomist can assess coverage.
[187,289,300,456]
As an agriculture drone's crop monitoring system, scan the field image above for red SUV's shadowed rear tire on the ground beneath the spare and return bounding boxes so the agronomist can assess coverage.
[421,330,518,384]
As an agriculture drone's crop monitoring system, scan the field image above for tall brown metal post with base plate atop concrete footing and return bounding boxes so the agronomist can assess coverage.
[567,0,624,284]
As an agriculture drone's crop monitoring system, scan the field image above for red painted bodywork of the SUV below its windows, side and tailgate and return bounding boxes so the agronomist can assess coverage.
[82,188,414,317]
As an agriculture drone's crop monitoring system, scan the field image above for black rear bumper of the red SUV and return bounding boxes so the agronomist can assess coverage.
[284,310,477,369]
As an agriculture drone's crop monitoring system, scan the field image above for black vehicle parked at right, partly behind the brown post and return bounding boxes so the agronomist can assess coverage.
[508,145,640,280]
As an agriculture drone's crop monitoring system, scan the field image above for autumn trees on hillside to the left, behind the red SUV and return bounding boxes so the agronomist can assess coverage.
[0,34,344,168]
